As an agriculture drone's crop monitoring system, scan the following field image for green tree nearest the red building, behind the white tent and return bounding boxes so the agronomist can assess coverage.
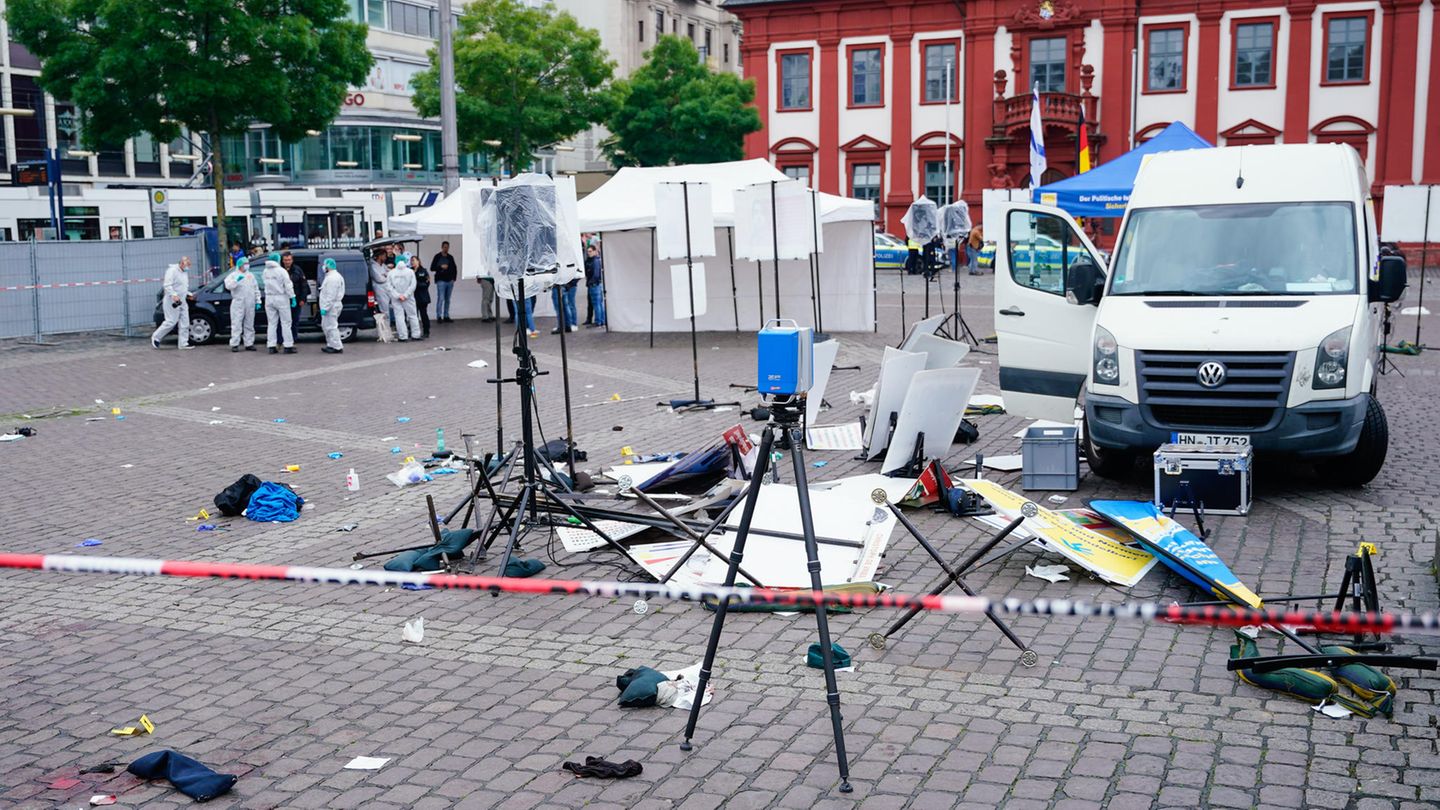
[605,36,760,166]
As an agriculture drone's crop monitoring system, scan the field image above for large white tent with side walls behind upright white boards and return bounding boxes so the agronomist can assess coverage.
[579,160,874,331]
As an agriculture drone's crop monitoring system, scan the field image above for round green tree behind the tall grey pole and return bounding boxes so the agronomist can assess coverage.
[412,0,615,172]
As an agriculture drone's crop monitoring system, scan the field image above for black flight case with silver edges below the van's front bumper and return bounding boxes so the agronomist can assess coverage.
[1155,444,1254,515]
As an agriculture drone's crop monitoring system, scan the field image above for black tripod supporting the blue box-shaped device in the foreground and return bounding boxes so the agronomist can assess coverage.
[680,396,854,793]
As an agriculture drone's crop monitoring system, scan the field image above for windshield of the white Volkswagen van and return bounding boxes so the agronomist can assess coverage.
[1110,202,1359,295]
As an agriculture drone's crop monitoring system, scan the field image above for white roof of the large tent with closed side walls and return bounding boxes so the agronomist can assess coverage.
[579,159,876,232]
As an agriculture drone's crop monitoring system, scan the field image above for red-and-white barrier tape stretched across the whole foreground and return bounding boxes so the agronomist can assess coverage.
[0,553,1440,633]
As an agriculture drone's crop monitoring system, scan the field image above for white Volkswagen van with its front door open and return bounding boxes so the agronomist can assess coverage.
[985,144,1405,486]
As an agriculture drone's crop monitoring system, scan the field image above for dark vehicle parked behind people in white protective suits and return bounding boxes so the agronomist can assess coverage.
[156,249,374,346]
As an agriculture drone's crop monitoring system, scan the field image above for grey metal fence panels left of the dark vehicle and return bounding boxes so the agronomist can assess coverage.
[0,236,209,342]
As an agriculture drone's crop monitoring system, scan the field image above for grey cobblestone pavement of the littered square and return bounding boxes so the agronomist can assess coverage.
[0,277,1440,809]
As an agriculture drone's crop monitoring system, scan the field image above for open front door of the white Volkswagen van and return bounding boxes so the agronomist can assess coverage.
[985,203,1106,424]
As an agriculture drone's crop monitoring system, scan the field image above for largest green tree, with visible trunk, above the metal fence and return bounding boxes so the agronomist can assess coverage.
[7,0,374,246]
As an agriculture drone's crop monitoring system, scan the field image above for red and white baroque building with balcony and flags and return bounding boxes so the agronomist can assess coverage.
[724,0,1440,232]
